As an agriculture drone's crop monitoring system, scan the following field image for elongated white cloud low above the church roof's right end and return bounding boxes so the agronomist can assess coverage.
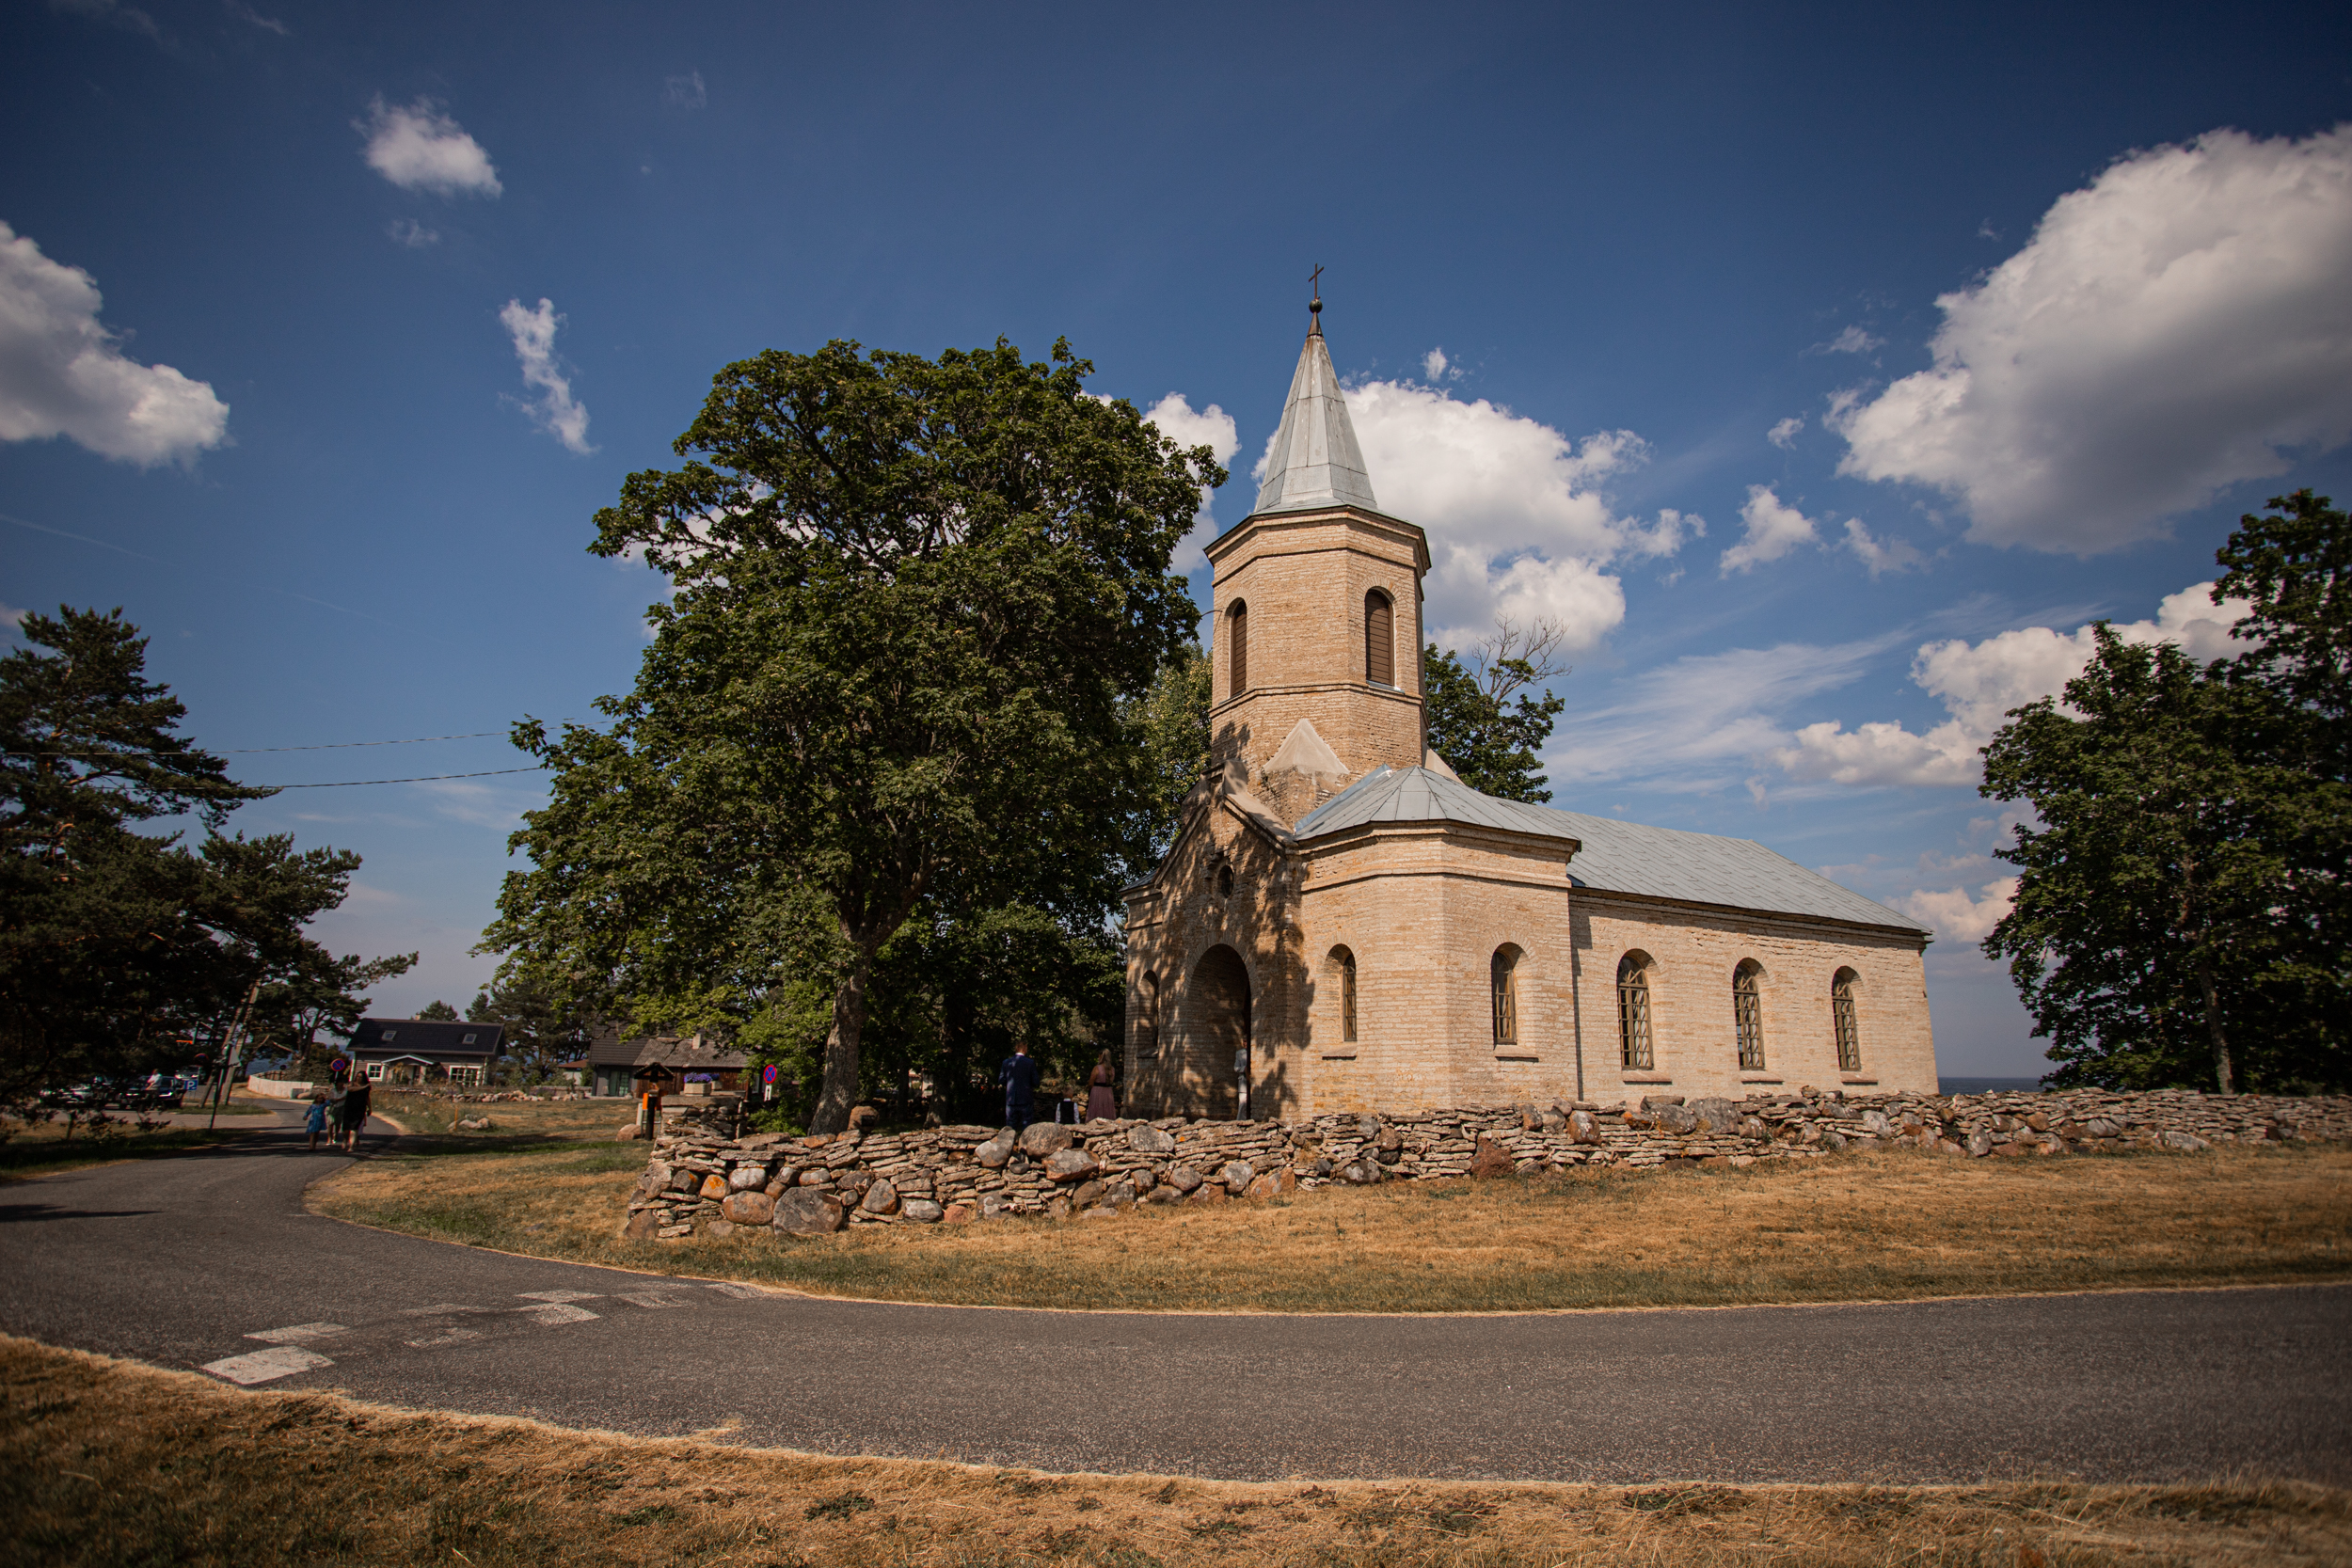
[1773,583,2249,785]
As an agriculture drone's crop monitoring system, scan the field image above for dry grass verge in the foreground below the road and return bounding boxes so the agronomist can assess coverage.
[0,1338,2352,1568]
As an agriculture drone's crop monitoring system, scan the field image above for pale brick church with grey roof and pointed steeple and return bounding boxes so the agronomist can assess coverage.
[1122,301,1936,1119]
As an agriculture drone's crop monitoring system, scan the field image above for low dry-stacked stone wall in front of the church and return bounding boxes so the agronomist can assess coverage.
[624,1091,2352,1239]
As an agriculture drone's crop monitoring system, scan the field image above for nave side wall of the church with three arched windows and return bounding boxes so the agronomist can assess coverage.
[1574,891,1936,1098]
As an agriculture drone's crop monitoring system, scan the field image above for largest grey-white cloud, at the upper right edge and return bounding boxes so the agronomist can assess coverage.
[1833,124,2352,555]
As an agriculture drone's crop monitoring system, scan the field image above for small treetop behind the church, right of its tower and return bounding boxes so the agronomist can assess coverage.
[1421,621,1566,806]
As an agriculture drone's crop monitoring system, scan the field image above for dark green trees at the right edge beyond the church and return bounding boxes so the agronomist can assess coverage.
[1983,491,2352,1093]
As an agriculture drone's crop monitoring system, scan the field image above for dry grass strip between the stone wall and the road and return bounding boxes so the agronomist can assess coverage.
[313,1145,2352,1312]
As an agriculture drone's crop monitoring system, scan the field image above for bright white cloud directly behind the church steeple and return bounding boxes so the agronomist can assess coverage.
[1327,380,1708,651]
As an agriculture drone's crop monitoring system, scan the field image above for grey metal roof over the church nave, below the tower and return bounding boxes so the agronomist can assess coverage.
[1296,768,1924,931]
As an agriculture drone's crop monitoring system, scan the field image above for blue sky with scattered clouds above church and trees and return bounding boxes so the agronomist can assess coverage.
[0,0,2352,1074]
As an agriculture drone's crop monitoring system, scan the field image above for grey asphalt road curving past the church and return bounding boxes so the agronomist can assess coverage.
[0,1109,2352,1486]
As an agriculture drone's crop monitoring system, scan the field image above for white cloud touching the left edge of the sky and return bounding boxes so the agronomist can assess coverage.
[0,223,229,466]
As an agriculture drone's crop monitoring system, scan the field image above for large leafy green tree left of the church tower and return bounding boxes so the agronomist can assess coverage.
[485,341,1226,1131]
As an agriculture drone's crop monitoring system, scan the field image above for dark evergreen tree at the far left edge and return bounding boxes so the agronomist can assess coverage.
[0,607,414,1107]
